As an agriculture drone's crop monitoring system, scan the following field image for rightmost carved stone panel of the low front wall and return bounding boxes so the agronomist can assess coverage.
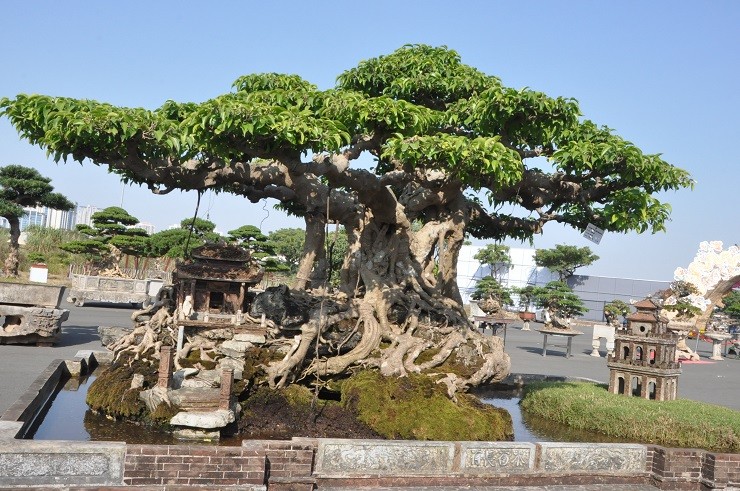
[539,442,647,474]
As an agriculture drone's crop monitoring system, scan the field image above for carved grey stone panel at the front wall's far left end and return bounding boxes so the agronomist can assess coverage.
[0,440,126,487]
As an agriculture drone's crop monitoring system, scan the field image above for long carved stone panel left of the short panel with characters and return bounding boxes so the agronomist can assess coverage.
[316,439,455,477]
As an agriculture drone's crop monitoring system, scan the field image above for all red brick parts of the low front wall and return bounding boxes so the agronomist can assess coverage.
[118,439,740,490]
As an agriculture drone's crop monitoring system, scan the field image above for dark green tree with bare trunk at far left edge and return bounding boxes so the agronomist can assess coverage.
[0,165,75,278]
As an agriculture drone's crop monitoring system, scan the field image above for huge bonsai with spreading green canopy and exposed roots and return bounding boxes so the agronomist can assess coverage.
[0,45,693,393]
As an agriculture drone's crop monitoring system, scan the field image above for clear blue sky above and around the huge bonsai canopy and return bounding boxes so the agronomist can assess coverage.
[0,0,740,280]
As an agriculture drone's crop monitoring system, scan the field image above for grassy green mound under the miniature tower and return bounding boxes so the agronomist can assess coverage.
[521,382,740,453]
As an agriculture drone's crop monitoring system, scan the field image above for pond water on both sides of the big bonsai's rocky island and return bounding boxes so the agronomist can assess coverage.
[27,375,625,446]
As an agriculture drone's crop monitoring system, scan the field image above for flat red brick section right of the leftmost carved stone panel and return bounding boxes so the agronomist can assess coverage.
[123,445,265,486]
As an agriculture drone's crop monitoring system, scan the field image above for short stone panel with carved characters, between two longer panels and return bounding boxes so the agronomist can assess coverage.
[460,442,537,474]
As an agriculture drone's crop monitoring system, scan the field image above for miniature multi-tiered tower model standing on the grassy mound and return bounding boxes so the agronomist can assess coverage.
[607,299,681,401]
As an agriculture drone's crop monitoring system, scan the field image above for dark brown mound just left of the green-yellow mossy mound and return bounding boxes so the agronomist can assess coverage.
[239,384,379,439]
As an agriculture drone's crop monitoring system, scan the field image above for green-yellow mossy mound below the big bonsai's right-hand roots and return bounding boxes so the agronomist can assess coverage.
[342,371,514,441]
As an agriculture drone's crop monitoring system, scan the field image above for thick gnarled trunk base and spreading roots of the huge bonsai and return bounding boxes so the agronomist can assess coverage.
[267,206,510,397]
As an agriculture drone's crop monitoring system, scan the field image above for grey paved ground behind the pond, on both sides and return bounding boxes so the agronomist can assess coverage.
[0,302,740,414]
